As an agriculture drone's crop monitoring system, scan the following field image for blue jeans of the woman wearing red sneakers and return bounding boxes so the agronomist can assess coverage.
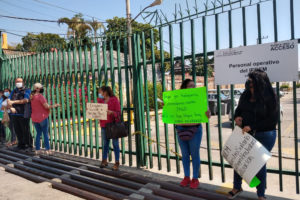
[176,125,202,179]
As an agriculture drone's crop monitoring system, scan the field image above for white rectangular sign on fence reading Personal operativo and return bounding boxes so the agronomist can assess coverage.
[214,40,299,85]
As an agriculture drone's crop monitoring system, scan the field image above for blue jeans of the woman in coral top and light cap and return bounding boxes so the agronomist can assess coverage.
[33,118,50,150]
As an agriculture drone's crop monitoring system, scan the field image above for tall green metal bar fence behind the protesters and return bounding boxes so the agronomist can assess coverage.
[0,0,299,193]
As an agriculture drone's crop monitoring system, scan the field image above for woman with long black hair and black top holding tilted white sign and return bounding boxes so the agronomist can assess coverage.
[228,69,279,200]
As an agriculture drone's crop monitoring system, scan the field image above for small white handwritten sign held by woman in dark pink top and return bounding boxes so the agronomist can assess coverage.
[86,103,108,120]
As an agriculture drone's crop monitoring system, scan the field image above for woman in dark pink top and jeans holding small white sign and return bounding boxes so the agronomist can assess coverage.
[98,86,121,171]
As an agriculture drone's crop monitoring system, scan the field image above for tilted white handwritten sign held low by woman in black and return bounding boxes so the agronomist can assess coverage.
[222,126,271,185]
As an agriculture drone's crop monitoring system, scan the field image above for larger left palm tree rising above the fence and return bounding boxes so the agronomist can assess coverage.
[58,13,91,39]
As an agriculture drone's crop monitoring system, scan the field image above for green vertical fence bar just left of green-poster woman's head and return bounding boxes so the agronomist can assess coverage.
[169,24,180,174]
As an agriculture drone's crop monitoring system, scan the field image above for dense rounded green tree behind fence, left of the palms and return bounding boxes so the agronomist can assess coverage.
[20,33,66,51]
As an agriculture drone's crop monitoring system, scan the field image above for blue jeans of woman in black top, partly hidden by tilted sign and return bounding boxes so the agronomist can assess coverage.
[233,130,276,197]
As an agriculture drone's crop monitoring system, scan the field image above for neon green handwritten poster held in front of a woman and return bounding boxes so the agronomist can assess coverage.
[162,87,208,124]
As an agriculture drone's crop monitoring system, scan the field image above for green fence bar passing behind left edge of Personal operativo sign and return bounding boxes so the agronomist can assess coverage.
[215,14,226,182]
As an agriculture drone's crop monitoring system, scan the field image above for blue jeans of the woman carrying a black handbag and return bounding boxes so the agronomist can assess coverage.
[101,128,120,162]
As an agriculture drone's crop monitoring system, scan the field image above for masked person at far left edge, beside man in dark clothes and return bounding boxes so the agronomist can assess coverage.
[1,88,17,147]
